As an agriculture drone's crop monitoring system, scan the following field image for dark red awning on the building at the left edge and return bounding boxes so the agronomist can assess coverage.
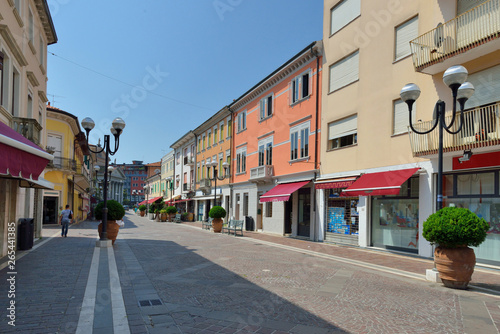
[0,122,54,181]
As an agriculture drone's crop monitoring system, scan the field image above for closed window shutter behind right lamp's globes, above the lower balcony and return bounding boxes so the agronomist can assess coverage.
[465,65,500,108]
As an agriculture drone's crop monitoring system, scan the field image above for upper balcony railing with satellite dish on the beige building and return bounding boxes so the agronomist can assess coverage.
[410,0,500,70]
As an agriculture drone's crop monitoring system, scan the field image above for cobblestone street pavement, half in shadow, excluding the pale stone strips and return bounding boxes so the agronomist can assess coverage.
[0,211,500,334]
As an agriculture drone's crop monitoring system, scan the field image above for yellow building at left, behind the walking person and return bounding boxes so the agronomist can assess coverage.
[43,106,93,224]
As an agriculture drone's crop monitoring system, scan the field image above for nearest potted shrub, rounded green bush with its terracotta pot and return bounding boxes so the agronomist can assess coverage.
[422,207,489,289]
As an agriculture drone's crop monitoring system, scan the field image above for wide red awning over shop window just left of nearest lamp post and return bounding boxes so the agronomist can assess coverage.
[342,168,419,196]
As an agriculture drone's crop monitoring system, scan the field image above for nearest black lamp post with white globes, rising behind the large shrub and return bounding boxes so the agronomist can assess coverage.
[400,65,474,211]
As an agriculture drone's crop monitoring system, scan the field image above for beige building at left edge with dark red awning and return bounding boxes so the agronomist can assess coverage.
[0,0,57,257]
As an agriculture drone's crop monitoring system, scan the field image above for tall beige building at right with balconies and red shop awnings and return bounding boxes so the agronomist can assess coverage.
[315,0,500,264]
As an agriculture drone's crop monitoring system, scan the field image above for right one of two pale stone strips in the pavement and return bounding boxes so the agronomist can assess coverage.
[108,247,130,334]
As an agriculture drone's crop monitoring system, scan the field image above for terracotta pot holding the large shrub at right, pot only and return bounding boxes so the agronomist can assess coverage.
[434,246,476,289]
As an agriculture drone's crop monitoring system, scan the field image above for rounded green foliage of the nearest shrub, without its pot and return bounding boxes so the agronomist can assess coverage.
[422,207,490,248]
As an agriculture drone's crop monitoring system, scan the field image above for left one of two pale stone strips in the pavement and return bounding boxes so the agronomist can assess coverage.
[76,247,101,334]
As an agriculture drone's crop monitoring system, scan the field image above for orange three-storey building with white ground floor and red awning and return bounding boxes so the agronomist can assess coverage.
[229,41,322,239]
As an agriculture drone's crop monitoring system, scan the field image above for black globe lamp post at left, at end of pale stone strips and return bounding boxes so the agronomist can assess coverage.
[82,117,125,240]
